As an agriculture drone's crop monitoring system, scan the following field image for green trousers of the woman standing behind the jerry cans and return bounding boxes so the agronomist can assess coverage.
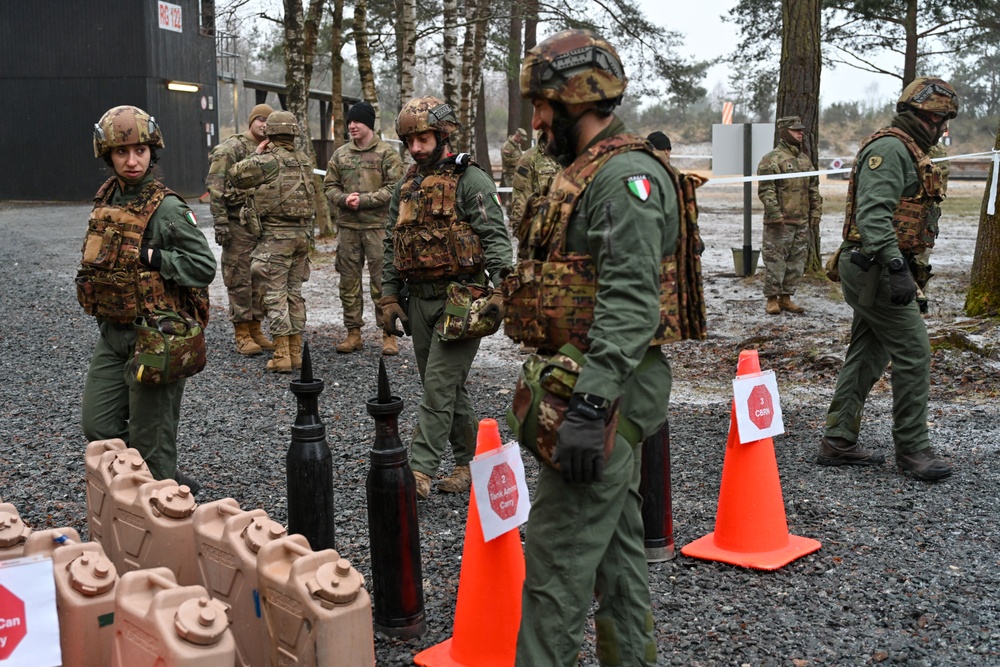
[82,322,185,479]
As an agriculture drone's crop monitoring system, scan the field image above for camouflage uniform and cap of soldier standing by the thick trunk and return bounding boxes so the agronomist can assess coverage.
[757,116,823,306]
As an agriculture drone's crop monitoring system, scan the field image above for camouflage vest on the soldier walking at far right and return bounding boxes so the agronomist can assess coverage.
[843,127,944,254]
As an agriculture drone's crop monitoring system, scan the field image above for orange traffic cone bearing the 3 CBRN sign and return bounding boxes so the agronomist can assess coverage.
[681,350,822,570]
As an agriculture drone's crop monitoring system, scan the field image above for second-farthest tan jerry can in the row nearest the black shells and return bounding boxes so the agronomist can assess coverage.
[111,473,198,586]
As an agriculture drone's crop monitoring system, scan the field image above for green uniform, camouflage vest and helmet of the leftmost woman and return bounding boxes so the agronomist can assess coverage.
[76,107,216,479]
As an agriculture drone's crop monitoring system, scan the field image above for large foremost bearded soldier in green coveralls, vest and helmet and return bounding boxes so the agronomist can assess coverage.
[504,30,680,667]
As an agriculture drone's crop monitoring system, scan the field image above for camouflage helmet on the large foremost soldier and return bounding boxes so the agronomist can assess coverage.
[521,30,628,104]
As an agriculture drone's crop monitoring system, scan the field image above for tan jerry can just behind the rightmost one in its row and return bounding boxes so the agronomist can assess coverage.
[193,498,288,667]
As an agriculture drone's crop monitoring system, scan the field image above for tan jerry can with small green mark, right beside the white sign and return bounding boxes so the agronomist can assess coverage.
[52,542,118,667]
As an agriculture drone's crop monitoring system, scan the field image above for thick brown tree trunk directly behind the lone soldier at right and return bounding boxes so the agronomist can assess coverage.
[777,0,823,274]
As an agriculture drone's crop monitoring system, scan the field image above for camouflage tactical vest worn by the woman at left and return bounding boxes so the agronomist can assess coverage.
[76,177,209,327]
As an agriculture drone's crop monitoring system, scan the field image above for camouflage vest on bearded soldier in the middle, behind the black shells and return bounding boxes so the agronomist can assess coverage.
[392,157,483,283]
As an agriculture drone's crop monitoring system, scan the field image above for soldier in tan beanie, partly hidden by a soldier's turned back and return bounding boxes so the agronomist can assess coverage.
[205,104,274,354]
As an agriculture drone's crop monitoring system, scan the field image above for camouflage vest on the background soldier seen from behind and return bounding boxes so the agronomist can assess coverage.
[252,146,316,227]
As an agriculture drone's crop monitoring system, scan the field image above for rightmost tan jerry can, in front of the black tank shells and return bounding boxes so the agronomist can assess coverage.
[257,535,375,667]
